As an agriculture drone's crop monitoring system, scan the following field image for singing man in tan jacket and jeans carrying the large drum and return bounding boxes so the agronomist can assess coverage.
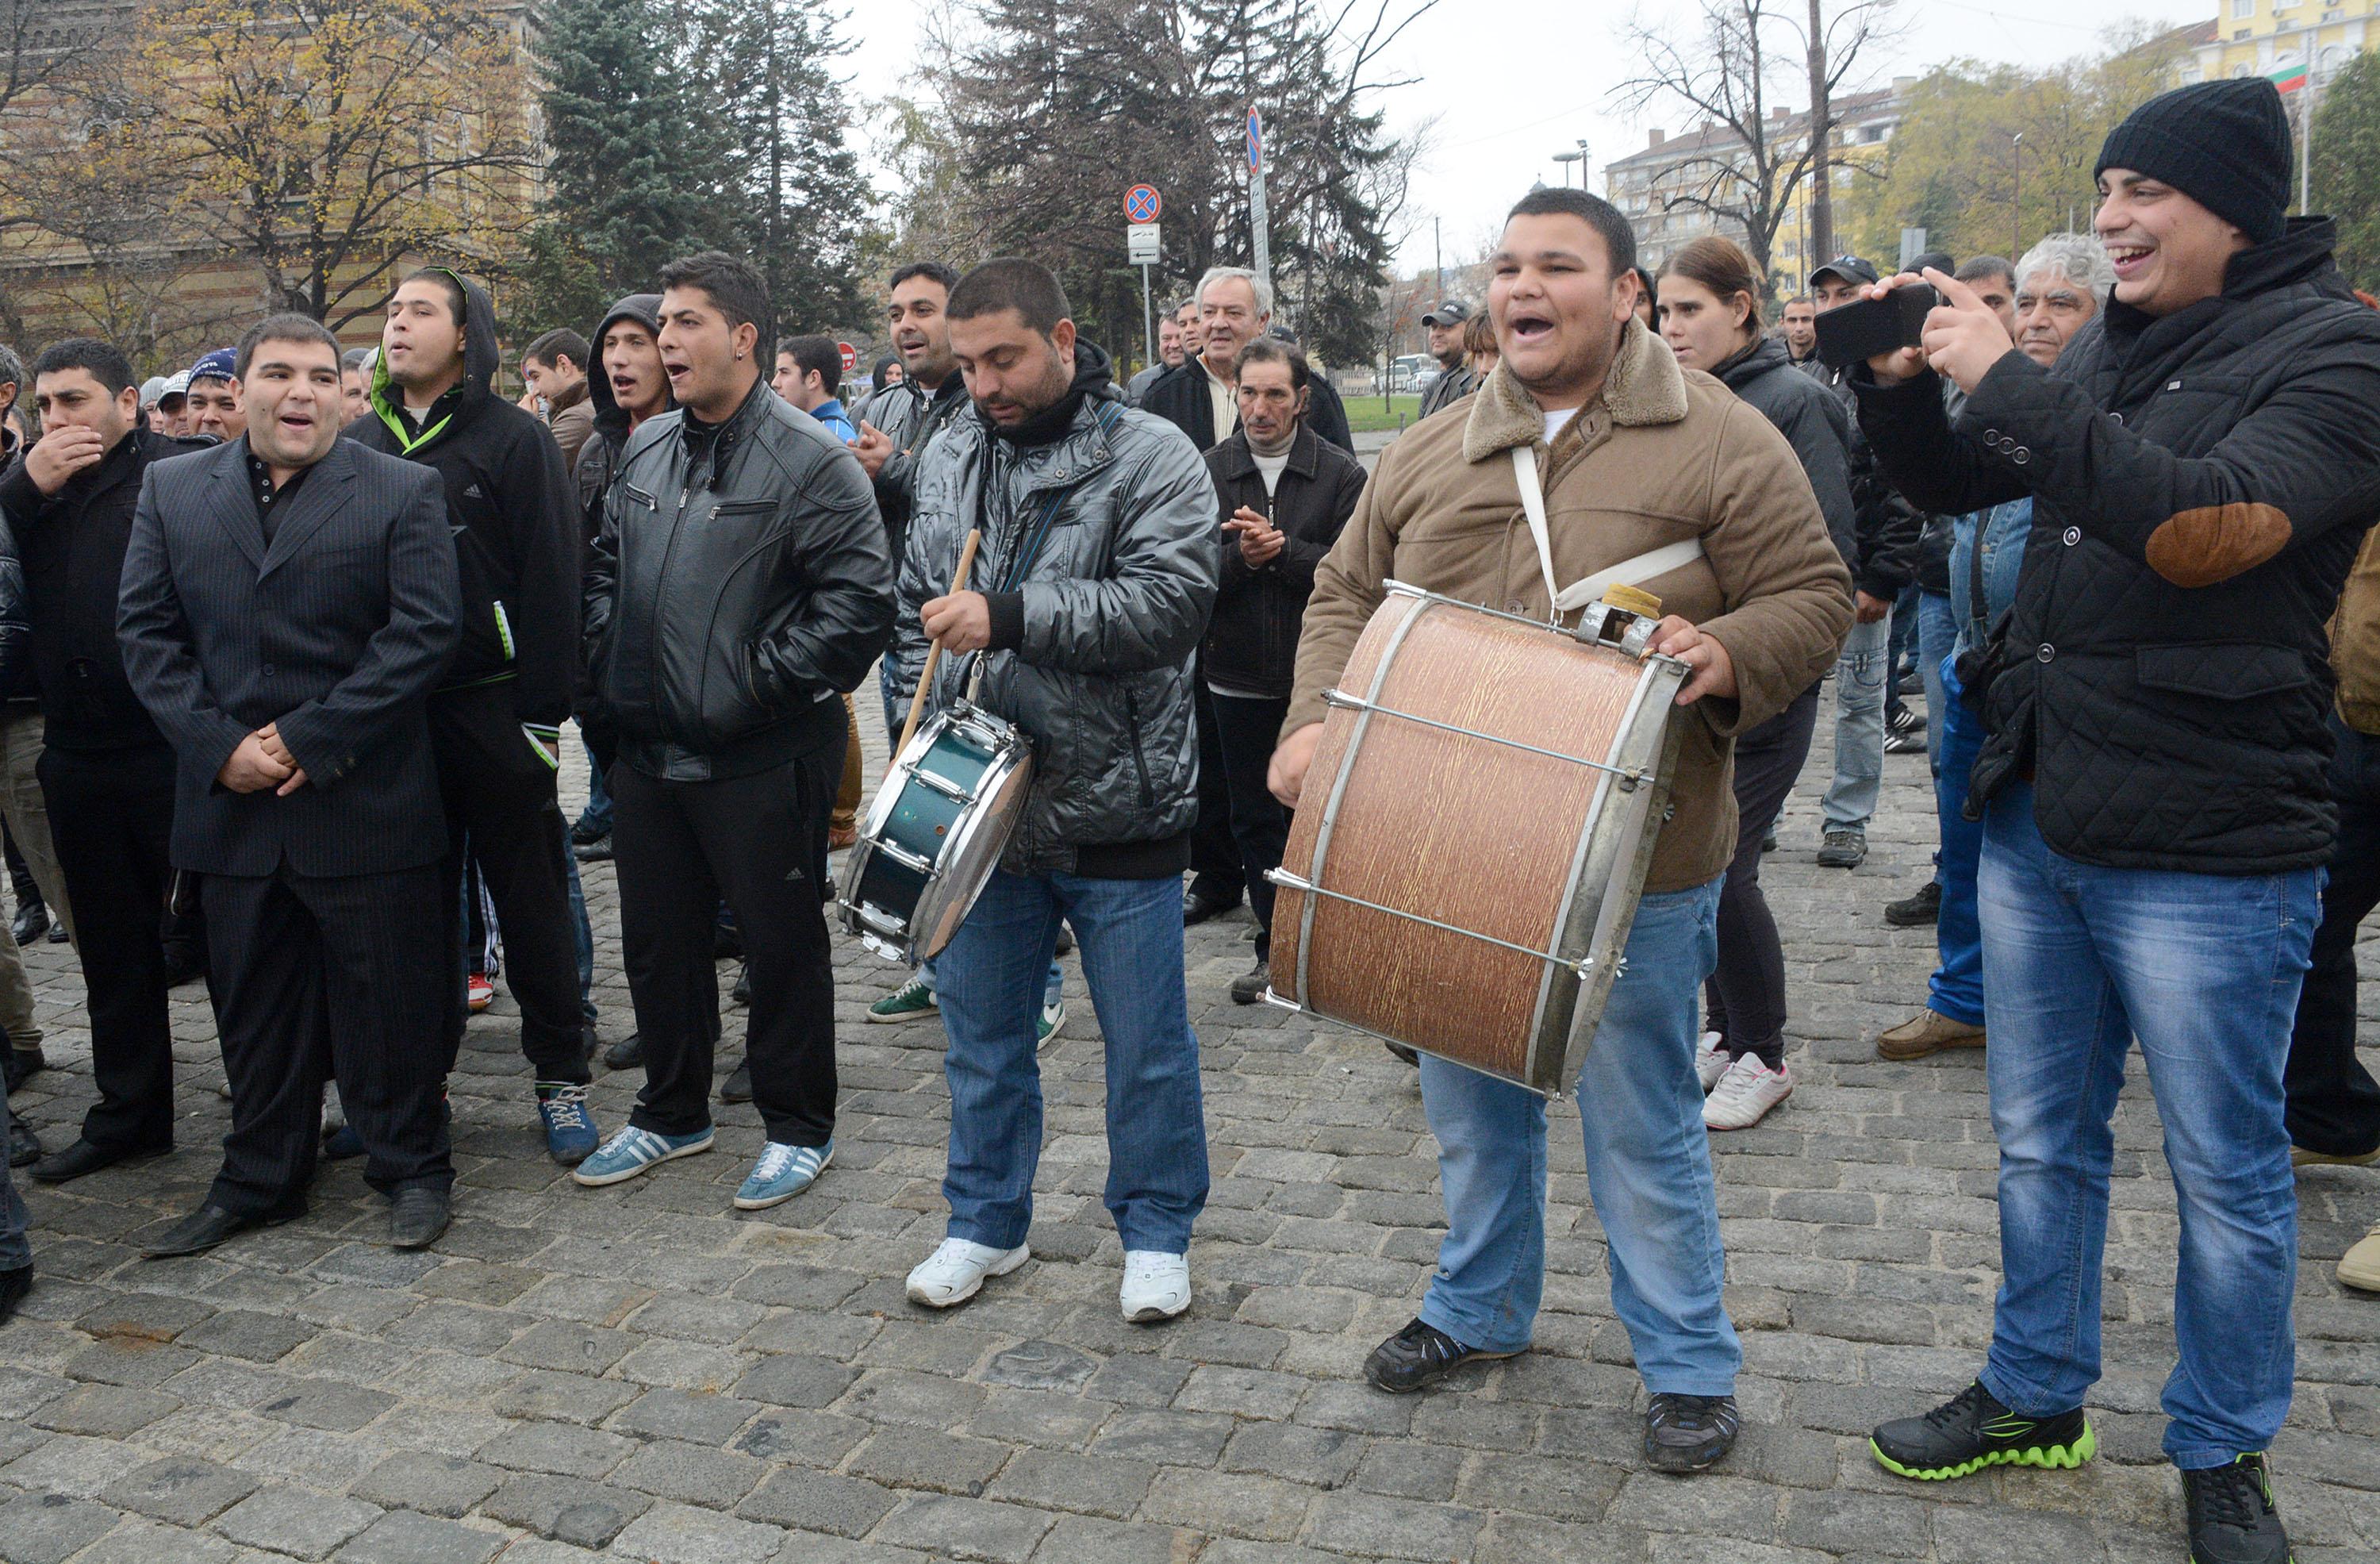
[1273,190,1852,1471]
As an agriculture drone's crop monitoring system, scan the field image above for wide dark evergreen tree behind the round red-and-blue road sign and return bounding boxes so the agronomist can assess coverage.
[923,0,1426,362]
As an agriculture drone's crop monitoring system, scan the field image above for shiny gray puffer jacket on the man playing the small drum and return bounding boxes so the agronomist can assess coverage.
[900,381,1221,878]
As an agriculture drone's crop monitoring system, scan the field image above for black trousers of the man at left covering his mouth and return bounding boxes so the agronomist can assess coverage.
[36,743,174,1152]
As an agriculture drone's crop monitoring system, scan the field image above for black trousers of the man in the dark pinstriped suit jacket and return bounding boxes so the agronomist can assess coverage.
[200,864,455,1212]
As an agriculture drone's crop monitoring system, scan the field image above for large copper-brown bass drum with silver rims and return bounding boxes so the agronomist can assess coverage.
[1266,581,1685,1095]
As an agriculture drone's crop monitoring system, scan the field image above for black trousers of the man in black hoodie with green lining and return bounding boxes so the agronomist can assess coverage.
[431,683,590,1086]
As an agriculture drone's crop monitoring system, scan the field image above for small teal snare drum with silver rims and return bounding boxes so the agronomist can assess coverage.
[835,700,1033,966]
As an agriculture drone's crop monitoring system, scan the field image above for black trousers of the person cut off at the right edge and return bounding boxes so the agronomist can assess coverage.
[2285,714,2380,1157]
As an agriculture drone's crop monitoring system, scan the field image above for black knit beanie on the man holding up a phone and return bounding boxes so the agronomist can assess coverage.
[2092,76,2290,245]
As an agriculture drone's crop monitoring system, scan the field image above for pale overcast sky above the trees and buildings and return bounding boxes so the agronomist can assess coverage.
[850,0,2218,269]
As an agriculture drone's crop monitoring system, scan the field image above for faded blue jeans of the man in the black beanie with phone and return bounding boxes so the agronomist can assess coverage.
[1978,786,2323,1471]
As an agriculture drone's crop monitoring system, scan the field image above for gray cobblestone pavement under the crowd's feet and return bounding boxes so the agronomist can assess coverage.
[0,676,2380,1564]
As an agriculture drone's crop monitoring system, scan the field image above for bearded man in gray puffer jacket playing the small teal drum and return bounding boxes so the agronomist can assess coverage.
[900,259,1221,1321]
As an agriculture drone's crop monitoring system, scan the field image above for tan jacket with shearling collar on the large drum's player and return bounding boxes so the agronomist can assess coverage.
[1283,319,1852,893]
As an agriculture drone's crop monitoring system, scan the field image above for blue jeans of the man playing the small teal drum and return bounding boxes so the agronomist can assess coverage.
[935,869,1207,1255]
